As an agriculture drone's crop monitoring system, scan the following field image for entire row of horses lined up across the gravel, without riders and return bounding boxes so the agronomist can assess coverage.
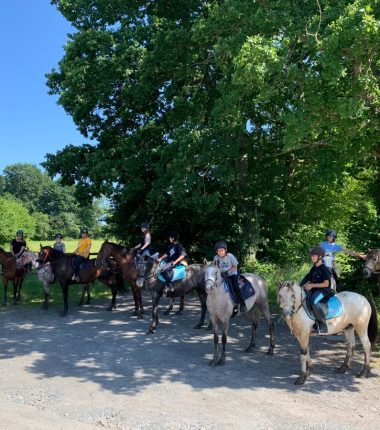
[0,240,380,384]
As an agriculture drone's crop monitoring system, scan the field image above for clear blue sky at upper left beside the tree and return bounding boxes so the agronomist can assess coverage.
[0,0,90,174]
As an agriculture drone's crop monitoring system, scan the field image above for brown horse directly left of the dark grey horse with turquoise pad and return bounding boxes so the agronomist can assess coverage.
[95,240,144,318]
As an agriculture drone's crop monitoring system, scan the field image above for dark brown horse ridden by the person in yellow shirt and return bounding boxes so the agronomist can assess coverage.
[37,246,107,316]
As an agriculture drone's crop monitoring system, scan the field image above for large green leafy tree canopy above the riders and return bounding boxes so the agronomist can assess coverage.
[44,0,380,261]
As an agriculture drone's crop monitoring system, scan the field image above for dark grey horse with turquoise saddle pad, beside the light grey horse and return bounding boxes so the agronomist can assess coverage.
[137,257,207,333]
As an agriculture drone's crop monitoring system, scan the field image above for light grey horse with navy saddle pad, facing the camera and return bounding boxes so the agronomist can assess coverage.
[204,263,275,367]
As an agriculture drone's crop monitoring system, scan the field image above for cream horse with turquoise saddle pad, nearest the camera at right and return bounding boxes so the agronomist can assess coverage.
[277,281,377,385]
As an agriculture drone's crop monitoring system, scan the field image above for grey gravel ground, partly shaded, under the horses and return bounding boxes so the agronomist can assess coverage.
[0,297,380,430]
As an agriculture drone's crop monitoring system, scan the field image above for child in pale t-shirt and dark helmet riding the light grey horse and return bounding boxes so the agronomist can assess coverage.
[214,240,247,314]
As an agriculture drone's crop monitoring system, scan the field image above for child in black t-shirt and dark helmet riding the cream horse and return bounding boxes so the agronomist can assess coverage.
[300,246,334,334]
